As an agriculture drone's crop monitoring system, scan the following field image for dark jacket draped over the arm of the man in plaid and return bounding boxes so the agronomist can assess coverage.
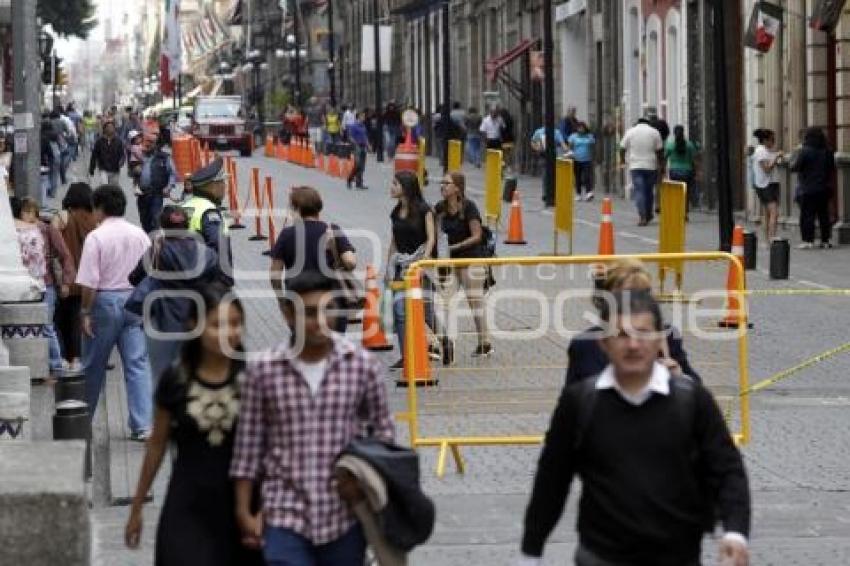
[343,438,436,552]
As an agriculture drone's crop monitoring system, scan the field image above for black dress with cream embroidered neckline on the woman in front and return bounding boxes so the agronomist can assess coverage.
[155,364,263,566]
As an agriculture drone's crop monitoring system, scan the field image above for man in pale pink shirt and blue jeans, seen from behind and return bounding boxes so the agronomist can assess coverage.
[77,185,152,441]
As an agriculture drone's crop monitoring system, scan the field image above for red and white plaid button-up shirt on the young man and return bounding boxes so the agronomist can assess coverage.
[230,337,393,545]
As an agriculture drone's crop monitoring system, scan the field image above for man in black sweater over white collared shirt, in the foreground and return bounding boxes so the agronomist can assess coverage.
[520,291,750,566]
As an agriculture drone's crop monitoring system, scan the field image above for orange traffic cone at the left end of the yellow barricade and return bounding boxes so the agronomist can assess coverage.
[396,270,438,387]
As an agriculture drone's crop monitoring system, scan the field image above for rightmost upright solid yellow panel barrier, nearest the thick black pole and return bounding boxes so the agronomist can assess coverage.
[658,180,688,295]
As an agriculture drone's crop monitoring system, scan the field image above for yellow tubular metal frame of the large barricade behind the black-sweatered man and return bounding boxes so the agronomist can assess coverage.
[396,252,750,477]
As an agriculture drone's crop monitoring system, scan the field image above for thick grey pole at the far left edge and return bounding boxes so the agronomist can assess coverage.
[12,2,40,205]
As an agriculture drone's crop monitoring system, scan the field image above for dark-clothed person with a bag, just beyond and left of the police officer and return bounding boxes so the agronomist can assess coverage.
[136,133,177,234]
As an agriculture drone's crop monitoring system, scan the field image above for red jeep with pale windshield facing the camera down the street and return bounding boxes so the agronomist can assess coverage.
[192,96,253,157]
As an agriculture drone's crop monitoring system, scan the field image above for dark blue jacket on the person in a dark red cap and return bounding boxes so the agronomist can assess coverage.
[125,238,221,332]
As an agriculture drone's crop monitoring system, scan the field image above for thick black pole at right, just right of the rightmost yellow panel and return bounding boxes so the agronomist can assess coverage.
[712,0,735,252]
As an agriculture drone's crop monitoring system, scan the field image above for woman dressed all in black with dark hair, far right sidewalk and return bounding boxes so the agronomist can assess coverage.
[791,128,835,250]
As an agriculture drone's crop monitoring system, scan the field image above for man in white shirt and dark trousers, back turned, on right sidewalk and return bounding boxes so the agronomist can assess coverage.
[620,118,664,226]
